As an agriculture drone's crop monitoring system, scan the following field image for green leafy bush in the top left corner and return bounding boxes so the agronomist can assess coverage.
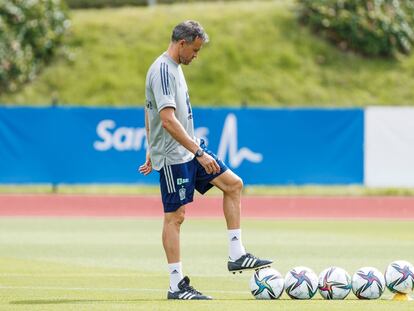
[0,0,69,92]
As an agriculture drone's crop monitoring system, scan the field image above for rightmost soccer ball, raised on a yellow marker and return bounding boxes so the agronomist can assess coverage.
[385,260,414,294]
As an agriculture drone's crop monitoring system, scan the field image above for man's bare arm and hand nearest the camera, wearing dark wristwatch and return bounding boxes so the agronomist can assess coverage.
[160,107,220,174]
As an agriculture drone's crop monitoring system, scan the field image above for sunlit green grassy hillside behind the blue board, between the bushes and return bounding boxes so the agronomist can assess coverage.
[0,1,414,106]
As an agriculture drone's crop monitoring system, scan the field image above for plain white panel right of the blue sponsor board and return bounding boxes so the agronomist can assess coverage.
[364,107,414,187]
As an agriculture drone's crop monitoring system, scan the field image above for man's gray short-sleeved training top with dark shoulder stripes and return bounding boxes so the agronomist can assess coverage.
[145,53,195,171]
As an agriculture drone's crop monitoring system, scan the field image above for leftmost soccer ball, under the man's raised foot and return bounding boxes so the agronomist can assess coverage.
[250,268,284,299]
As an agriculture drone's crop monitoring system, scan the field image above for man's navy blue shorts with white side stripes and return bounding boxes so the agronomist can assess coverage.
[159,140,227,213]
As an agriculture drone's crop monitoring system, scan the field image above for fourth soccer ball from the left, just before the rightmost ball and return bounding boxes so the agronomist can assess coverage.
[352,267,385,299]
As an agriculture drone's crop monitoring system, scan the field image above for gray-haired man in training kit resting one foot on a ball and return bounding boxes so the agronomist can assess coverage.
[139,21,272,299]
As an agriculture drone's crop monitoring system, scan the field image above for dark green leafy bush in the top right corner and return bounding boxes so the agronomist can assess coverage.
[299,0,414,56]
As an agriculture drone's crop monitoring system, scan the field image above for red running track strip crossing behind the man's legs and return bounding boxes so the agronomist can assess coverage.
[0,194,414,219]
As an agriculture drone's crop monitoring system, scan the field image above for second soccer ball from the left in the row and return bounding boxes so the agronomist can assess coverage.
[285,267,318,299]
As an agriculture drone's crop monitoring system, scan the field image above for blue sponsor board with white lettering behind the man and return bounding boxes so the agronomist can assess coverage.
[0,107,364,185]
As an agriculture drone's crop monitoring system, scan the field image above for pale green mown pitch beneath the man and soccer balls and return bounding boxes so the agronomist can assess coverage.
[0,218,414,311]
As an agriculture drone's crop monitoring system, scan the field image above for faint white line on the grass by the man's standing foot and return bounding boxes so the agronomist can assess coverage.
[0,285,248,295]
